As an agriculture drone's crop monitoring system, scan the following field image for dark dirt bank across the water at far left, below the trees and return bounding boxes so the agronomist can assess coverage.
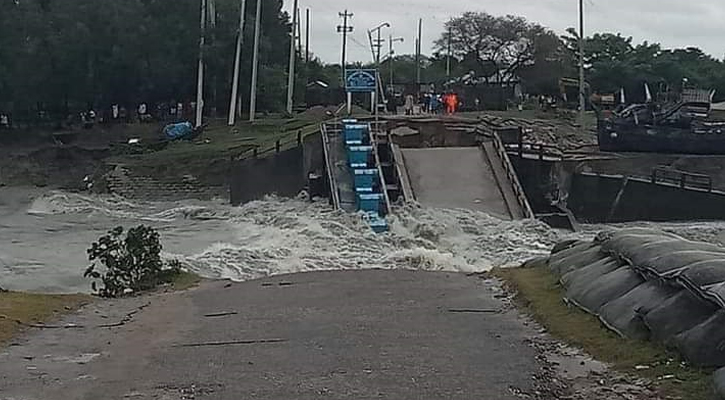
[0,124,228,192]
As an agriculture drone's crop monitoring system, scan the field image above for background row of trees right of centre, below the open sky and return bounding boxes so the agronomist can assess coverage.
[381,12,725,101]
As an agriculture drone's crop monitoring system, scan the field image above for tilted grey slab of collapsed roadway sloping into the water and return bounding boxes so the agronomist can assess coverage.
[401,147,511,219]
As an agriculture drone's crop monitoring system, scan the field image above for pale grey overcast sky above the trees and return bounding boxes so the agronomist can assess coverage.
[284,0,725,63]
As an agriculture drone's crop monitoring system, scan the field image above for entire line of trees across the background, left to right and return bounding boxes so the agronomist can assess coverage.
[0,0,725,125]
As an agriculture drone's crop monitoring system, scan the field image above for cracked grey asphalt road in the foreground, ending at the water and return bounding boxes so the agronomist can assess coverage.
[0,271,539,400]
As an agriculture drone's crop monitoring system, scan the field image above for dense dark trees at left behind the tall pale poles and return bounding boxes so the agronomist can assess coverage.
[0,0,291,120]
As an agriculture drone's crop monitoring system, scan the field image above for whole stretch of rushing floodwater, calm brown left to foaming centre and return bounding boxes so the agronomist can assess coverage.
[0,188,561,293]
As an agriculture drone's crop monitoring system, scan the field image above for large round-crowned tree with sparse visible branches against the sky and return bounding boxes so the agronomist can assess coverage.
[435,12,558,84]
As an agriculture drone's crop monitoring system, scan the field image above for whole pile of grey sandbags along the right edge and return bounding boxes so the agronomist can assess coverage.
[547,229,725,395]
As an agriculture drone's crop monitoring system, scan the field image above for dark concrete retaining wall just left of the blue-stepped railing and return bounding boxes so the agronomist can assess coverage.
[229,134,325,205]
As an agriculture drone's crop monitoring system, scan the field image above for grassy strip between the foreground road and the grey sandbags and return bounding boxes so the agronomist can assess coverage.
[494,266,713,400]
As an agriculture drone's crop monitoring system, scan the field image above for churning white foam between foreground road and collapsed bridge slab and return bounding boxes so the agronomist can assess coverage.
[167,198,559,281]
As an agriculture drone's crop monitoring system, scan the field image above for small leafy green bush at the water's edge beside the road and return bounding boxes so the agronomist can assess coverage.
[83,225,181,297]
